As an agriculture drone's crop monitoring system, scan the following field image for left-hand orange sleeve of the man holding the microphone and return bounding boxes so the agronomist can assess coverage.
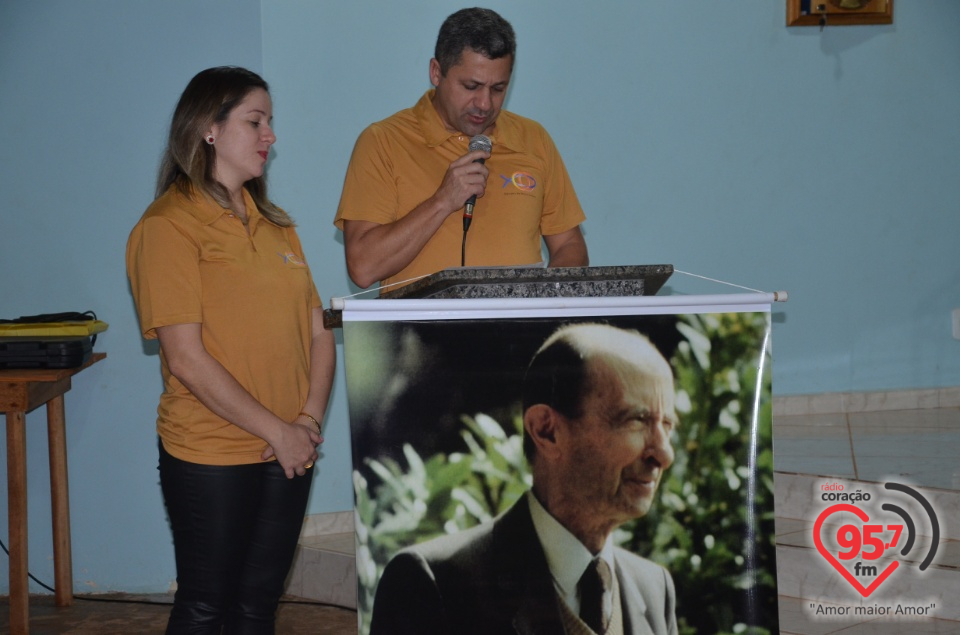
[333,124,398,230]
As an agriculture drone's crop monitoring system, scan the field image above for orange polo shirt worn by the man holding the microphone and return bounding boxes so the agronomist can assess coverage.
[334,90,585,288]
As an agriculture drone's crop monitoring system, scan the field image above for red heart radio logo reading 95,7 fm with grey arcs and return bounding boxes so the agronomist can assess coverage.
[813,483,940,598]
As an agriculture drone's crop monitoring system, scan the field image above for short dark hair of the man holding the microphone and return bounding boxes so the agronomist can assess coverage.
[433,8,517,75]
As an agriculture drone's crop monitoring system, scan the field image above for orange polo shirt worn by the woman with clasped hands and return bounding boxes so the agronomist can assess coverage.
[127,188,320,465]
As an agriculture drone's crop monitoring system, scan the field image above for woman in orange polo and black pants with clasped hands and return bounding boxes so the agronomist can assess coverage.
[126,67,335,633]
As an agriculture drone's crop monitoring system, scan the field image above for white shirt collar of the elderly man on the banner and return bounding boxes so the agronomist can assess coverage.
[527,491,616,606]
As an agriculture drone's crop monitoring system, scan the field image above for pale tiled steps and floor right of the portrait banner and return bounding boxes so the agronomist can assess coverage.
[774,405,960,635]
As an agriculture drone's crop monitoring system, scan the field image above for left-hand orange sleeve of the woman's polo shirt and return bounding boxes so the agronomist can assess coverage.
[127,216,203,339]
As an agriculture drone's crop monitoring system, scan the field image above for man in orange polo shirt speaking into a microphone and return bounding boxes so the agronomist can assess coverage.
[334,9,589,289]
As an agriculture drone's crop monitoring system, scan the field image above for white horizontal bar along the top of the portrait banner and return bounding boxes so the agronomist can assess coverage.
[330,291,787,322]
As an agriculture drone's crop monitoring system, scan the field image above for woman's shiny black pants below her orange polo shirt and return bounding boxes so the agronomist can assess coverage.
[160,444,313,635]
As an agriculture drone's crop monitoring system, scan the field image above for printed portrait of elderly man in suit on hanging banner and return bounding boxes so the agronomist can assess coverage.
[344,312,779,635]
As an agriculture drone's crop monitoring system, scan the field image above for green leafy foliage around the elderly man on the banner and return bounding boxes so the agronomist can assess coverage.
[354,313,779,635]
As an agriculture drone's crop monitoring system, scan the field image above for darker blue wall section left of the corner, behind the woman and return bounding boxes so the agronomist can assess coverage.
[0,0,263,593]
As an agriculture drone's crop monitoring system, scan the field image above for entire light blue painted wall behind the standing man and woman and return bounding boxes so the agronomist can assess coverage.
[0,0,960,593]
